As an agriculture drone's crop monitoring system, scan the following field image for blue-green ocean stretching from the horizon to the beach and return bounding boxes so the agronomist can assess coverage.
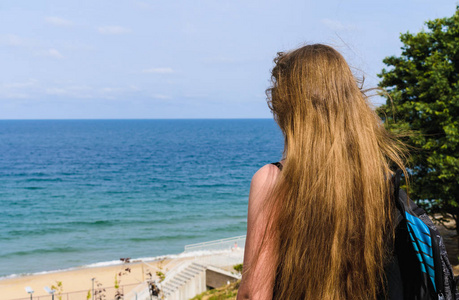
[0,119,283,276]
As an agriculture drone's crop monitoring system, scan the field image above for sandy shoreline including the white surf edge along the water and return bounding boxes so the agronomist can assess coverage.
[0,248,242,300]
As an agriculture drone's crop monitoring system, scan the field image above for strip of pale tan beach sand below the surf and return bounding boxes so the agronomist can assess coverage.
[0,259,170,300]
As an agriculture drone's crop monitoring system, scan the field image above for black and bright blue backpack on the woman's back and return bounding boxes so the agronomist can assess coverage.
[386,170,459,300]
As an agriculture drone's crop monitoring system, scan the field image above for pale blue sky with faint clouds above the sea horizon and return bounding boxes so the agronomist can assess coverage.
[0,0,458,119]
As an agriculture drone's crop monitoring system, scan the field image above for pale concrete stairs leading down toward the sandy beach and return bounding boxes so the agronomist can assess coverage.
[161,261,207,300]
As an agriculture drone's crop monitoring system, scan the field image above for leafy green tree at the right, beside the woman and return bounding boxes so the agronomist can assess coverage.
[377,5,459,239]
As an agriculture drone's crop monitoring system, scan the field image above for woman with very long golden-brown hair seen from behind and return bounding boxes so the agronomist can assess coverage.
[237,44,406,300]
